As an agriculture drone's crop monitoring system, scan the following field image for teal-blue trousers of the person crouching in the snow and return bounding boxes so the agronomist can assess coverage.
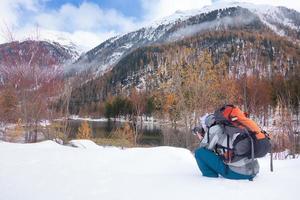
[195,148,253,180]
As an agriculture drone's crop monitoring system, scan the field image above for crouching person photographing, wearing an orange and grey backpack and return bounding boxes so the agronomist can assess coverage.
[193,105,271,180]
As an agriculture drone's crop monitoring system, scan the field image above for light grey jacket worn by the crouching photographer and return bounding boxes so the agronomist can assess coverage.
[200,115,259,175]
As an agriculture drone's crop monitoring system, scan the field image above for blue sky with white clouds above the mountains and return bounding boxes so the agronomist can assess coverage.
[0,0,300,50]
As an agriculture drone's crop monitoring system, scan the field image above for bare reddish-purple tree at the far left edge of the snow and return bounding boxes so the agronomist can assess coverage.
[0,28,62,142]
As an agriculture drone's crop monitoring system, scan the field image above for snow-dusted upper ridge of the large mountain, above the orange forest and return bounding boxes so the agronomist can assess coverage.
[69,2,300,74]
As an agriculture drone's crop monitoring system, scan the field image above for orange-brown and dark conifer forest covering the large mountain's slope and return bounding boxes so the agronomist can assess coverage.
[72,29,300,120]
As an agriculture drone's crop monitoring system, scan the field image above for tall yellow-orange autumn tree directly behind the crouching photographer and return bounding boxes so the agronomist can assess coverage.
[156,47,238,147]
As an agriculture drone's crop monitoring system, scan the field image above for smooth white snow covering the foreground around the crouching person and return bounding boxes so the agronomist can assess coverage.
[0,140,300,200]
